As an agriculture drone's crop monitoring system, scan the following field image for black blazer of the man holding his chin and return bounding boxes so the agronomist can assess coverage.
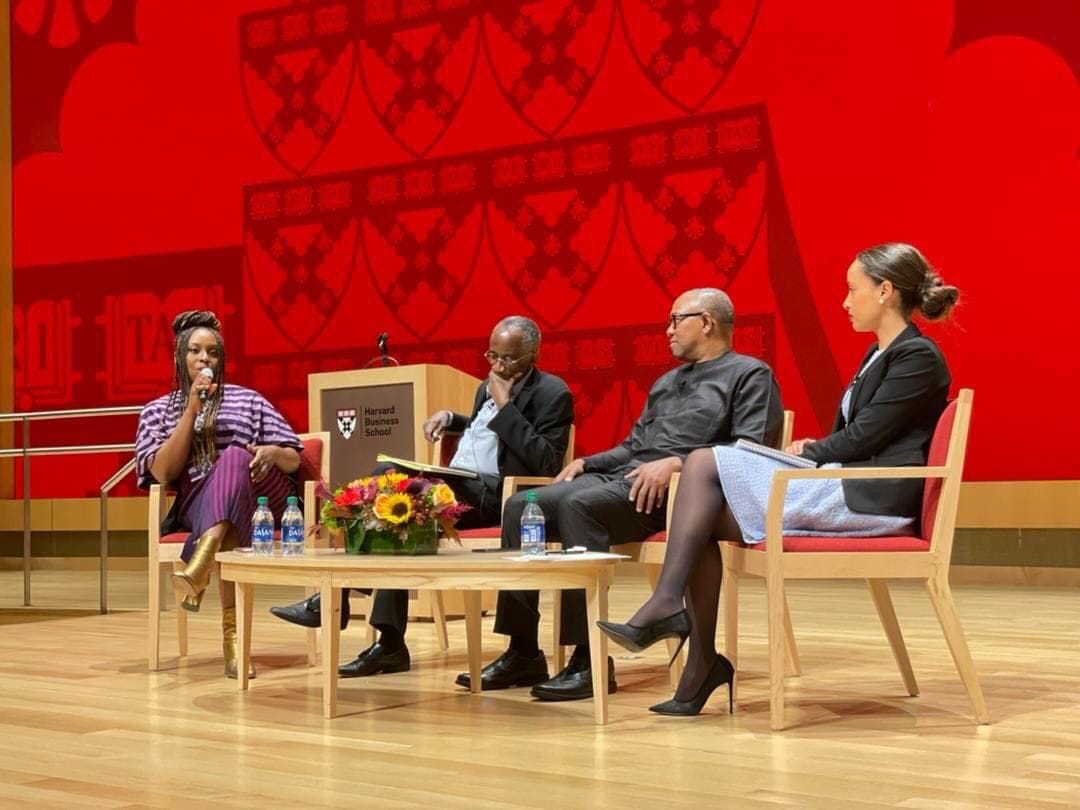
[447,368,573,488]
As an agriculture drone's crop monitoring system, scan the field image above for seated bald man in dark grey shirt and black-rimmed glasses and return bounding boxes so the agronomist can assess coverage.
[457,288,784,701]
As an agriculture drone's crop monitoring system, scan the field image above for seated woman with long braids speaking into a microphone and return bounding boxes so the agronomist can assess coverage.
[135,310,302,678]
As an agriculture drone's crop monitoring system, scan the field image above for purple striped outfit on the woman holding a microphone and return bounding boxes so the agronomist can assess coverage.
[135,384,303,561]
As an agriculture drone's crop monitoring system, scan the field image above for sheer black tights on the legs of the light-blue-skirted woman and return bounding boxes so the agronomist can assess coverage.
[630,448,742,700]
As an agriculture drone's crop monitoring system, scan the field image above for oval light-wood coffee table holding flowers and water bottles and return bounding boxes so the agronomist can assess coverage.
[217,549,623,725]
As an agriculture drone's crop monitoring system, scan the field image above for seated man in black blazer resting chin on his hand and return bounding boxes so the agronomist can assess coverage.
[270,315,573,677]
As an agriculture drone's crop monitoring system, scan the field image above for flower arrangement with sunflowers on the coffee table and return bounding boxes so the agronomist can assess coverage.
[319,470,470,542]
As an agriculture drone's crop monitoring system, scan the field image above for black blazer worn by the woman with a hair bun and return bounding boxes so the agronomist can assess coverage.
[802,324,951,517]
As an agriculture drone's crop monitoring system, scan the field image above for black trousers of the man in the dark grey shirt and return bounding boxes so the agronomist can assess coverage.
[495,473,666,646]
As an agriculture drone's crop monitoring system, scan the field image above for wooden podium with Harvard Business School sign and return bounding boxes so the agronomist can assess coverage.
[308,364,494,619]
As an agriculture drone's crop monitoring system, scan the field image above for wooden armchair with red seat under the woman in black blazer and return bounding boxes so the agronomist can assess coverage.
[721,389,989,730]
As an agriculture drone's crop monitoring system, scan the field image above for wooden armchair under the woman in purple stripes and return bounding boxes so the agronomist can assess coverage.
[147,432,330,671]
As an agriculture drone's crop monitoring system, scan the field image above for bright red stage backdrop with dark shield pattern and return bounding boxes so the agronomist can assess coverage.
[12,0,1080,497]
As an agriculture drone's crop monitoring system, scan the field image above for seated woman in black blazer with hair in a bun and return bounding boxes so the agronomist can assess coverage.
[600,243,959,715]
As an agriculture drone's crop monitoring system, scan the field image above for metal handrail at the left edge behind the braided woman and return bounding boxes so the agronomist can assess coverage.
[0,405,143,613]
